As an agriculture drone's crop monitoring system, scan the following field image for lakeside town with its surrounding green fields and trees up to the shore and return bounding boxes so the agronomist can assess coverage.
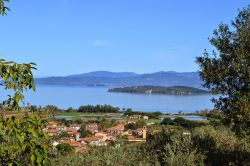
[38,105,214,153]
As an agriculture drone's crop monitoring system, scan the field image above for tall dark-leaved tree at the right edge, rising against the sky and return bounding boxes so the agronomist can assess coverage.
[197,5,250,137]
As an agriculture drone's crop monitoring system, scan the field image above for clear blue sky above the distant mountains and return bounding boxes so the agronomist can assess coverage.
[0,0,249,76]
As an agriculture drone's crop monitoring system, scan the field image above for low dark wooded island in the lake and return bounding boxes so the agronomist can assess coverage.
[108,85,209,95]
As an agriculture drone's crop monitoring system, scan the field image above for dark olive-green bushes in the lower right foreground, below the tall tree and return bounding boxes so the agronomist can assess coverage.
[142,126,250,166]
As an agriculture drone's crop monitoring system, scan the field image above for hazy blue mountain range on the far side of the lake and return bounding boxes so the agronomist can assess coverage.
[35,71,202,88]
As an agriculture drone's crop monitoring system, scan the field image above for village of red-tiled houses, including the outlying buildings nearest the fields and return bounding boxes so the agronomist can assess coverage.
[44,115,148,153]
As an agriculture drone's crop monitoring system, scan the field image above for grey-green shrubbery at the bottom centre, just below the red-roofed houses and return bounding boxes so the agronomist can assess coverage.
[54,145,159,166]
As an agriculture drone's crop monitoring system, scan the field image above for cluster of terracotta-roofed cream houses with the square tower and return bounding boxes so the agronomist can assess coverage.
[44,118,146,153]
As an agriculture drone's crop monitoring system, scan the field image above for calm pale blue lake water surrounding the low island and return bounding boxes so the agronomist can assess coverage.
[0,86,213,113]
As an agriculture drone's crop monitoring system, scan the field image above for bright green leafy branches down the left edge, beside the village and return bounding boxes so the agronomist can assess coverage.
[0,59,49,165]
